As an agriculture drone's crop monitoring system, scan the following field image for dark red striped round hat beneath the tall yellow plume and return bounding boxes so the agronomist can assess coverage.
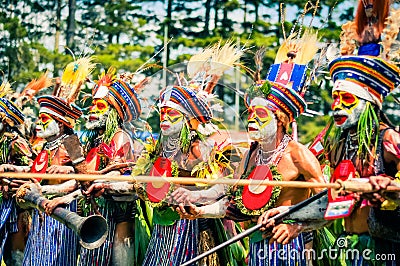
[38,95,82,128]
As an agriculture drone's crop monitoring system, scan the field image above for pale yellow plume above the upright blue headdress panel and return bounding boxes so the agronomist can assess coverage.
[275,30,319,65]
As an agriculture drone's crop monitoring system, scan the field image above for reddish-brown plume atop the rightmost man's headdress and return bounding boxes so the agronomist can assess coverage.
[354,0,390,44]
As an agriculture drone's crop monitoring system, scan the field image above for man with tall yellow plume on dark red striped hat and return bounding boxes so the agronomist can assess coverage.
[19,58,94,266]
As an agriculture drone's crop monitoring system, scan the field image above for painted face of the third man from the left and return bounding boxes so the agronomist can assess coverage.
[86,99,110,129]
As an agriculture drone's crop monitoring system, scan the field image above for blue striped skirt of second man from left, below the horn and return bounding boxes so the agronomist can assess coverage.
[23,201,78,266]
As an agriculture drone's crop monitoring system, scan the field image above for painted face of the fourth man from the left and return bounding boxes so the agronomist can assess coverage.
[160,107,184,136]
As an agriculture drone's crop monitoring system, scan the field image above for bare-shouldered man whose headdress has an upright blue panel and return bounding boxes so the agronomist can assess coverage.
[181,32,324,265]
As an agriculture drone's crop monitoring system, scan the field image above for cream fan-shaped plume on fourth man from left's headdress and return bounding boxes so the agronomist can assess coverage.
[205,41,243,93]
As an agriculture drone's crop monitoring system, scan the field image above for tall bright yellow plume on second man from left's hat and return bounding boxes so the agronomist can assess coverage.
[58,56,96,103]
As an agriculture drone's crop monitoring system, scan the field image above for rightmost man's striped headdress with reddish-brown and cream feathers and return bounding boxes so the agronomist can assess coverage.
[329,0,400,108]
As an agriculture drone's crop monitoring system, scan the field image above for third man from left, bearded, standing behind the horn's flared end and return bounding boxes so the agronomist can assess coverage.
[79,68,141,265]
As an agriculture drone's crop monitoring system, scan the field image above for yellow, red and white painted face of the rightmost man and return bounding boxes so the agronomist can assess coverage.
[332,91,366,129]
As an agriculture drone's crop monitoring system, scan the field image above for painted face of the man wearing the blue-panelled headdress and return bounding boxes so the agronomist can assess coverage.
[248,105,278,141]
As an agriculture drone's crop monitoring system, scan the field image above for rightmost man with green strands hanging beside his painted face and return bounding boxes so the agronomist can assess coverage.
[329,1,400,265]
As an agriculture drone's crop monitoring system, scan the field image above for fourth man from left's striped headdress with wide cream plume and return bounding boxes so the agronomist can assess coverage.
[159,41,243,135]
